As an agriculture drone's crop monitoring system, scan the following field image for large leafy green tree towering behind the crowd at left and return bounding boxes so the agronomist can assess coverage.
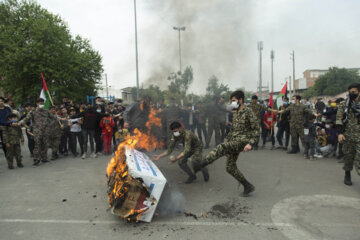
[0,0,103,102]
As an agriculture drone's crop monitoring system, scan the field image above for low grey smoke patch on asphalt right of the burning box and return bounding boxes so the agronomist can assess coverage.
[156,182,186,217]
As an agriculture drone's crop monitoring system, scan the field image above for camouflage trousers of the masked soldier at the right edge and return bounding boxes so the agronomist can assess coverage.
[343,137,360,175]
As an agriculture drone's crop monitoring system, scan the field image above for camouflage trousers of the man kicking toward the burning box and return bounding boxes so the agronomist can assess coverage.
[205,140,247,181]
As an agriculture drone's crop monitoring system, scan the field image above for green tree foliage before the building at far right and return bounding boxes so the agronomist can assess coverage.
[303,67,360,97]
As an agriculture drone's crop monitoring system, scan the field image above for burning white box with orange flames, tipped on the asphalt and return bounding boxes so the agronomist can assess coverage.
[107,107,166,222]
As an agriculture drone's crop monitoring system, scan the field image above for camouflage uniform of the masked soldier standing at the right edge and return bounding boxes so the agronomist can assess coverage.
[336,99,360,175]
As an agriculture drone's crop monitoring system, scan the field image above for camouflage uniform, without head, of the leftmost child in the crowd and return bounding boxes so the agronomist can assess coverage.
[3,126,24,167]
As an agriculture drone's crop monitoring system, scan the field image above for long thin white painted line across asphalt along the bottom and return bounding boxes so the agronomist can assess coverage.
[0,219,360,228]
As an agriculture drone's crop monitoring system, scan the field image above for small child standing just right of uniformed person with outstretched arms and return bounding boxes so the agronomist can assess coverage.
[304,114,316,160]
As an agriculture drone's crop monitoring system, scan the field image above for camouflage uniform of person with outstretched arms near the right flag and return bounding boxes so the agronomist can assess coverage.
[282,104,312,150]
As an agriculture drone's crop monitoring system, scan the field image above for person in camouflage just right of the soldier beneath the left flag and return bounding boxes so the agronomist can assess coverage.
[49,106,62,160]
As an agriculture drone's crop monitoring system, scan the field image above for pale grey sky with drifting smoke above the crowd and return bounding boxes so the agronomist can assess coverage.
[38,0,360,94]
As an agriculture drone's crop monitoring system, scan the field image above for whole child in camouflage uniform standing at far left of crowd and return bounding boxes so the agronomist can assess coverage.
[3,113,24,169]
